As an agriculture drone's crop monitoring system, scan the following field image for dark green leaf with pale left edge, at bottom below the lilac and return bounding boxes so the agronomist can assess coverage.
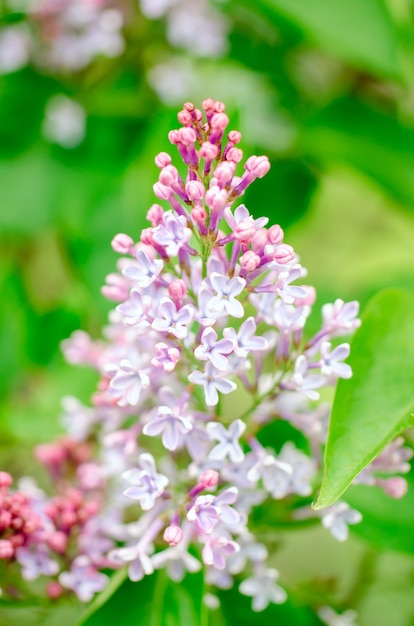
[78,571,206,626]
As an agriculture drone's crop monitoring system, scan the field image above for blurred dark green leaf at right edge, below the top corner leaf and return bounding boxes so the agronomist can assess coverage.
[301,98,414,207]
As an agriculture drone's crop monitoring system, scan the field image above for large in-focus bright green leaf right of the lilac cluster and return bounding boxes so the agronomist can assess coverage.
[314,289,414,509]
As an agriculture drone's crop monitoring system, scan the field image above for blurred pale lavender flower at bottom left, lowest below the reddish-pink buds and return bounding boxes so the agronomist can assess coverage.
[59,555,109,602]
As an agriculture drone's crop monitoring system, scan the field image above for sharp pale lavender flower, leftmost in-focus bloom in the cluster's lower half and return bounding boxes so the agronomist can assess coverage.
[122,452,168,511]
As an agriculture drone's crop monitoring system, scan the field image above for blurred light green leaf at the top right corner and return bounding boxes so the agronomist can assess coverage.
[261,0,401,78]
